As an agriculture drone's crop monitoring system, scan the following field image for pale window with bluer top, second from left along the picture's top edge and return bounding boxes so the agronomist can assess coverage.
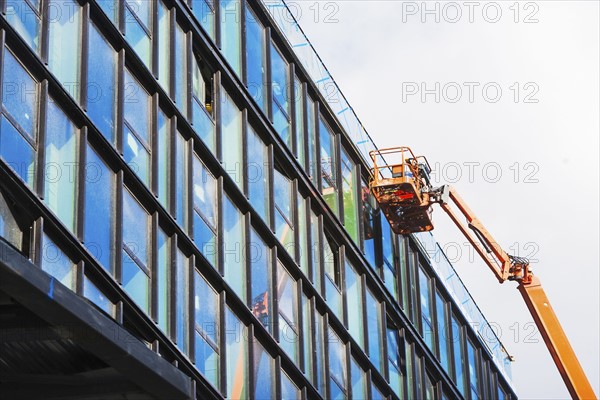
[48,0,82,100]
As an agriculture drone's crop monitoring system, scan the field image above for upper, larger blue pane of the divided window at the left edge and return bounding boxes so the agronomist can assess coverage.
[2,50,38,140]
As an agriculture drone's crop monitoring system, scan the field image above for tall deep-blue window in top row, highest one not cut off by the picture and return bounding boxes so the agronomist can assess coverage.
[246,6,268,112]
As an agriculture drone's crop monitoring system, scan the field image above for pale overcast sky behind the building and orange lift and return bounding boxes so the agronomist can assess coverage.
[288,0,600,399]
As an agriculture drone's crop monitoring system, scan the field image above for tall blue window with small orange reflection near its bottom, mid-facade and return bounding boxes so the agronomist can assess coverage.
[247,229,273,332]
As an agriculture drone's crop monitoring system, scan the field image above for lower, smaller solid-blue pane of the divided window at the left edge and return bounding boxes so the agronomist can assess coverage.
[0,115,35,187]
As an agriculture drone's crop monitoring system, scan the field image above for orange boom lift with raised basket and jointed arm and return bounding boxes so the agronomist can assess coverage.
[370,147,596,399]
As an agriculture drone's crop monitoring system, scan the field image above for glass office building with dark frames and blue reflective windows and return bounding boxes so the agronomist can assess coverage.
[0,0,516,400]
